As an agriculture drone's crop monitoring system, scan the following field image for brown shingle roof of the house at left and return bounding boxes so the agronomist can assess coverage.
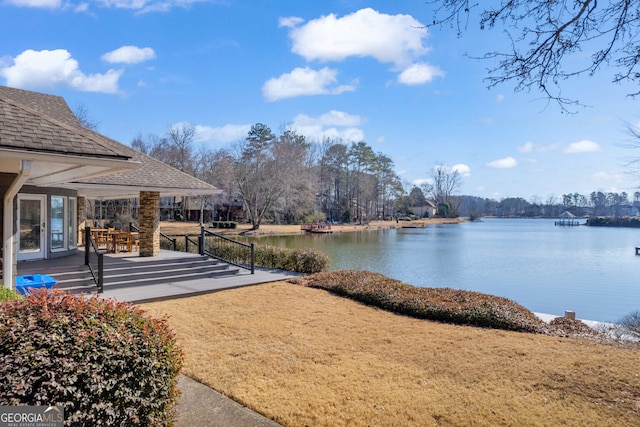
[0,86,219,196]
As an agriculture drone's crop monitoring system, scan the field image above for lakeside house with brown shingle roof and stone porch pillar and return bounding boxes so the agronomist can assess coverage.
[0,86,220,287]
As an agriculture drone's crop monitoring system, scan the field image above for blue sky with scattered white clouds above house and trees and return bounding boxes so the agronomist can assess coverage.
[0,0,640,201]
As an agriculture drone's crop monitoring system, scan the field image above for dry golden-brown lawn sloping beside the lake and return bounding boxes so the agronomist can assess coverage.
[144,282,640,426]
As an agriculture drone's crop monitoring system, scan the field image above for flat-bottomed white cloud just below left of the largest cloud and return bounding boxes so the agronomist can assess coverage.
[262,67,355,101]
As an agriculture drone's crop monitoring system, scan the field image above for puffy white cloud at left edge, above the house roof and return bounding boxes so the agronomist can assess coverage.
[0,49,122,93]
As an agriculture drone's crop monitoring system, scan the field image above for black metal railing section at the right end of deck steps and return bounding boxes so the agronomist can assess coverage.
[199,227,256,274]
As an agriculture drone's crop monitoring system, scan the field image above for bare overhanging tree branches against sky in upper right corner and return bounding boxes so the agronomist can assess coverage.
[427,0,640,109]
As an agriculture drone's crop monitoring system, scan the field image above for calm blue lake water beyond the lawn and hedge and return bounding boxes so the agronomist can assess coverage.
[249,219,640,321]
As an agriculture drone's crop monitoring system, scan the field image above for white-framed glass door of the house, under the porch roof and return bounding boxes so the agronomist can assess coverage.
[18,194,47,261]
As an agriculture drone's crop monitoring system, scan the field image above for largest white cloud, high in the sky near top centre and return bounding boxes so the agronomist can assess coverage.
[290,8,429,69]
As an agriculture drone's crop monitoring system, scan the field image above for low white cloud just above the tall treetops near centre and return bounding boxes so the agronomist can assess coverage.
[289,110,364,142]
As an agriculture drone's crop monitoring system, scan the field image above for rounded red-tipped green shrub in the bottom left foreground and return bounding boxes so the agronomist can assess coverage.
[0,290,182,426]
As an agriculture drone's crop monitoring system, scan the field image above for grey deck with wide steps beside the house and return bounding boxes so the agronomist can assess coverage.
[17,250,297,303]
